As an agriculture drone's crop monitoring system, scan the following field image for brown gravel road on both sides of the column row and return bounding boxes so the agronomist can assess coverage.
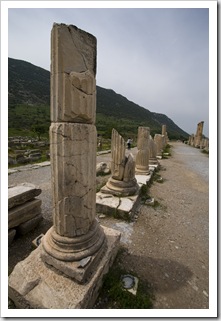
[8,142,209,309]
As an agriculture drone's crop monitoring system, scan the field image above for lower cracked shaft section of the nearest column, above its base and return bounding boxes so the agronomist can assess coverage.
[50,123,97,237]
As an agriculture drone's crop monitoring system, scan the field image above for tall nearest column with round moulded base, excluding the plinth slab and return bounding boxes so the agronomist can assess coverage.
[42,24,105,282]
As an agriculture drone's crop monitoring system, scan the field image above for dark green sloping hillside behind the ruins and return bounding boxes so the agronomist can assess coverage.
[8,58,189,140]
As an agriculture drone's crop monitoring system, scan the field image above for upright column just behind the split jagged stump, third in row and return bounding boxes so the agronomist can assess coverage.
[135,127,150,175]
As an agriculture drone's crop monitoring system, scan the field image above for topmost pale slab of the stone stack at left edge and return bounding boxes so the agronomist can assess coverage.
[8,183,41,209]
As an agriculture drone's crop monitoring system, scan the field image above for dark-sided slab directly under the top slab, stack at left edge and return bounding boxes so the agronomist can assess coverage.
[8,199,41,229]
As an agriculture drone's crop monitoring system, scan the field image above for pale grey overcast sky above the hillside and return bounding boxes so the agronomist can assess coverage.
[5,1,216,136]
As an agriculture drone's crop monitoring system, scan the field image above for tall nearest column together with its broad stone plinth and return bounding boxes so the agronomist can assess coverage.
[9,24,121,309]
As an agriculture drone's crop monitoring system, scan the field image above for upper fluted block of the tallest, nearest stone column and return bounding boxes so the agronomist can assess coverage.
[51,24,97,124]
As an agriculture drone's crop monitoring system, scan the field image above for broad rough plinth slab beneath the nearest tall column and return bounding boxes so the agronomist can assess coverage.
[9,227,120,309]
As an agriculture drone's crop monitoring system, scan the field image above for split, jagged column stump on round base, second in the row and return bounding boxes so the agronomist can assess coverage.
[101,129,139,196]
